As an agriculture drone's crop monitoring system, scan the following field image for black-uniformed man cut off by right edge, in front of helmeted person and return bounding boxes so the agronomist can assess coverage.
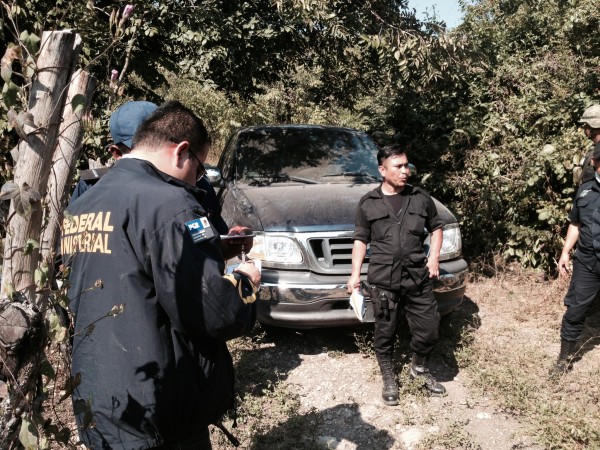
[551,146,600,375]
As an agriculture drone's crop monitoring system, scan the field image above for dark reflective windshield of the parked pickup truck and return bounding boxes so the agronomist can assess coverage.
[236,127,380,185]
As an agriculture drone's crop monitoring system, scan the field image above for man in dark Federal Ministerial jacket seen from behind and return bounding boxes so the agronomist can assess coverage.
[61,102,260,450]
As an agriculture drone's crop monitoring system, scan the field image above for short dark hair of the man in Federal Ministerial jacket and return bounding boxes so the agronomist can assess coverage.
[133,100,210,151]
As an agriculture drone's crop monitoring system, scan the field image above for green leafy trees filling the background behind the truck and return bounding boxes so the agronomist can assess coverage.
[0,0,600,268]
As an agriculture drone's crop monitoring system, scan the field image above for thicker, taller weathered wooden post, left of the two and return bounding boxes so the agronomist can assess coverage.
[0,30,76,302]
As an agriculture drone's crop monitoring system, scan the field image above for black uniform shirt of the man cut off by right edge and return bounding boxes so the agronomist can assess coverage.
[569,178,600,270]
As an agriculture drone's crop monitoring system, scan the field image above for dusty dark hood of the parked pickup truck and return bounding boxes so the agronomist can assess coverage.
[224,183,456,232]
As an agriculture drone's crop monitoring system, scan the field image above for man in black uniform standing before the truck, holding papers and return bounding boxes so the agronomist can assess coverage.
[348,145,446,405]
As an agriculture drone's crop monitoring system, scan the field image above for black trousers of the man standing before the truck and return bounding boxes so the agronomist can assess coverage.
[373,274,440,356]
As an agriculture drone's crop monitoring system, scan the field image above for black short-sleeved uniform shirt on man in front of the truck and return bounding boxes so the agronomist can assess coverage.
[353,185,443,290]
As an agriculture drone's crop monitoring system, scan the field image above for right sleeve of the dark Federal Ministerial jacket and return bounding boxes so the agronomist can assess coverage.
[149,207,256,341]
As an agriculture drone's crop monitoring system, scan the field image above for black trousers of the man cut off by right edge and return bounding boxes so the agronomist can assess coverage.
[560,258,600,341]
